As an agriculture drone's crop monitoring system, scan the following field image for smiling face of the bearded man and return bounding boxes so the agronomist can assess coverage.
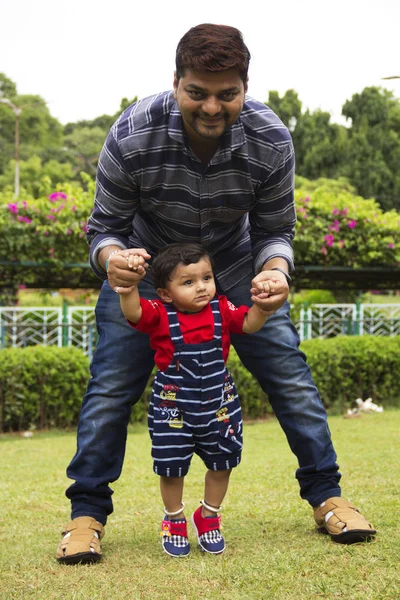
[174,69,247,142]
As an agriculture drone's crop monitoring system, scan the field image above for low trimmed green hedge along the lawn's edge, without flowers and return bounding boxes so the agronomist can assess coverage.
[0,336,400,432]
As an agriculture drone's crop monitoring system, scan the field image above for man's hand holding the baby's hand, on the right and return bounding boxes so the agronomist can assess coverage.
[250,270,289,315]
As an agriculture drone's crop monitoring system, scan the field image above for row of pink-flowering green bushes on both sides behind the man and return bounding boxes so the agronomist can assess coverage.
[0,175,400,287]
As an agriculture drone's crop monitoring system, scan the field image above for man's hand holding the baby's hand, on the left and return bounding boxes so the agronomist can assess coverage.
[107,248,151,294]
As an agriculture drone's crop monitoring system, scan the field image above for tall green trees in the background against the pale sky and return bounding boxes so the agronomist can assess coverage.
[0,73,400,211]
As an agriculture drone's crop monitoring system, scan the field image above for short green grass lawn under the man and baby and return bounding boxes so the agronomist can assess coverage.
[0,410,400,600]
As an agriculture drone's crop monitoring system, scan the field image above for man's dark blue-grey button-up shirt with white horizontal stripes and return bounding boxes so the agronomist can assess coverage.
[87,91,296,291]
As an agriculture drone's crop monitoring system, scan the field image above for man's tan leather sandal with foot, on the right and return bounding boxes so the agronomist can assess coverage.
[314,496,376,544]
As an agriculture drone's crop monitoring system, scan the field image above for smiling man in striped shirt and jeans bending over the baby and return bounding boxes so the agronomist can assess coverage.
[57,24,376,563]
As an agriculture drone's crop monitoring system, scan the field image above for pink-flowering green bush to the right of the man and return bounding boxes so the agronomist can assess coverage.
[294,180,400,268]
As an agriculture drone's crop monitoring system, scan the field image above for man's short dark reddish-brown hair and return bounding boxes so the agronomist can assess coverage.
[175,23,250,83]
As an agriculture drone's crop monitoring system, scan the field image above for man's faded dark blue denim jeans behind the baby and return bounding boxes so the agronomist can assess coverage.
[66,276,340,524]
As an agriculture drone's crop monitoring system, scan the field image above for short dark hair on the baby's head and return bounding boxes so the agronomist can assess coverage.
[151,244,212,290]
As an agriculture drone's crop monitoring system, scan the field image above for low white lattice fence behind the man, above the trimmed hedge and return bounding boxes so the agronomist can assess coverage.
[0,304,400,357]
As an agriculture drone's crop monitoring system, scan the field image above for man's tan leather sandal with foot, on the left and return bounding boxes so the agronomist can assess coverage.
[57,517,104,565]
